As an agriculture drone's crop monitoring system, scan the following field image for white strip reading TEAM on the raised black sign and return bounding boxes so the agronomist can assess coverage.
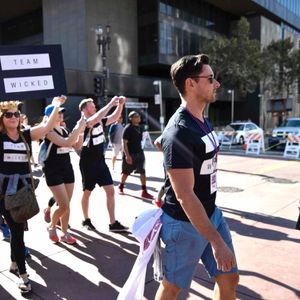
[0,53,51,71]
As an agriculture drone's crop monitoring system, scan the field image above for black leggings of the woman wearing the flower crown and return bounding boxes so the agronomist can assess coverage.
[0,199,26,274]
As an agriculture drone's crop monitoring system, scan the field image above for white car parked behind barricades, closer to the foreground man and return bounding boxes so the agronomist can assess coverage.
[219,121,264,145]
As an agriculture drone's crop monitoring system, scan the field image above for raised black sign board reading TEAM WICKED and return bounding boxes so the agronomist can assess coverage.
[0,45,67,101]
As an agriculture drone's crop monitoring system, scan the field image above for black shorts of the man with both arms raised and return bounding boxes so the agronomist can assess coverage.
[79,160,113,191]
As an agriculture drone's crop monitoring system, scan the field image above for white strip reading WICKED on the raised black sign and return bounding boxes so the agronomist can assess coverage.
[4,75,54,93]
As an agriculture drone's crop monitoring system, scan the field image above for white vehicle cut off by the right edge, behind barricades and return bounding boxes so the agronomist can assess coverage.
[269,118,300,149]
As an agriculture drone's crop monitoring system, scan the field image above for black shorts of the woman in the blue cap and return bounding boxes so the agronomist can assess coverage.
[43,164,75,186]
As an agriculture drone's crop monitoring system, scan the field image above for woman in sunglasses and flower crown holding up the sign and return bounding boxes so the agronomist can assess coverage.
[0,97,65,293]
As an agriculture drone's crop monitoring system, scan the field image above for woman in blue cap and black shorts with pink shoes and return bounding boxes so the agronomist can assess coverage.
[43,105,85,244]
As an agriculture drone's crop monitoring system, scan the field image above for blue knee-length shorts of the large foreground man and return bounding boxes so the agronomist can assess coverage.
[160,207,237,289]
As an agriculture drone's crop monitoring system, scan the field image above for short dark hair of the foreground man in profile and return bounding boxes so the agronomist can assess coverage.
[170,54,209,95]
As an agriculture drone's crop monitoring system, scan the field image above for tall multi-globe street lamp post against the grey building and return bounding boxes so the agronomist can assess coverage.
[95,25,111,105]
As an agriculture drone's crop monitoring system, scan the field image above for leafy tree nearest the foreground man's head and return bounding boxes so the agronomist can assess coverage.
[202,17,261,95]
